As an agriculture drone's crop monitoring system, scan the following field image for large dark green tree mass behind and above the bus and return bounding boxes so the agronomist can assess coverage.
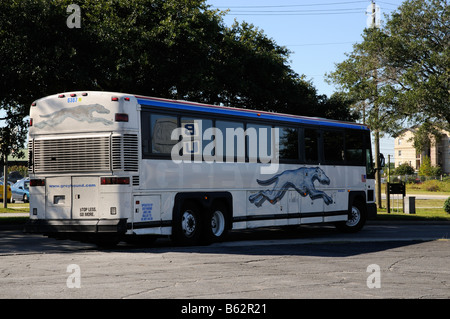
[0,0,353,156]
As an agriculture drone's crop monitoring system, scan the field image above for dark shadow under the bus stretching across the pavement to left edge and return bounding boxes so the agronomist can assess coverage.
[0,226,432,257]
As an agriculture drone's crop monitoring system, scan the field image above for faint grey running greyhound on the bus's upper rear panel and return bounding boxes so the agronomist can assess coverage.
[35,104,113,128]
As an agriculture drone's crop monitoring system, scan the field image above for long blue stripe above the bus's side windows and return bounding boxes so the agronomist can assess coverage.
[137,98,369,130]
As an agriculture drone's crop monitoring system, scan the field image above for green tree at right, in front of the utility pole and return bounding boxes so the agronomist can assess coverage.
[328,0,450,206]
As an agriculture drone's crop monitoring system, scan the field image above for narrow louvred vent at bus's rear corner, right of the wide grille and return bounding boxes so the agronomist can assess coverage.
[112,134,139,172]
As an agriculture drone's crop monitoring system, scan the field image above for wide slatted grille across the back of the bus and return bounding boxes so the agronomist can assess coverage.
[29,136,110,173]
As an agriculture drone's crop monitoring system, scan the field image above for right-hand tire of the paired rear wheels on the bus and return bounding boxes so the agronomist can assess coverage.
[205,202,229,242]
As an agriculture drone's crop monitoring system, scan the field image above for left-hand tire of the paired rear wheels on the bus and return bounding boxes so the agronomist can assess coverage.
[173,201,203,245]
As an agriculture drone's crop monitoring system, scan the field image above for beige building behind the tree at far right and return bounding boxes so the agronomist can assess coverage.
[394,128,450,174]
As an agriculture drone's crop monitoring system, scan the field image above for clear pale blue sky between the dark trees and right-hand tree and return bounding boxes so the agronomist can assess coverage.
[207,0,403,158]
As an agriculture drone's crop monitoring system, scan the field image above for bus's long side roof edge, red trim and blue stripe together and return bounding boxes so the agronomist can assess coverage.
[135,95,369,130]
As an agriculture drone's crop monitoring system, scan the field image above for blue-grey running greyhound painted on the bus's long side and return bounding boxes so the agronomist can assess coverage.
[248,167,333,207]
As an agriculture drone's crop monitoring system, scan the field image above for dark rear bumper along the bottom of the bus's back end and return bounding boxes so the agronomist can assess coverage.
[24,218,127,234]
